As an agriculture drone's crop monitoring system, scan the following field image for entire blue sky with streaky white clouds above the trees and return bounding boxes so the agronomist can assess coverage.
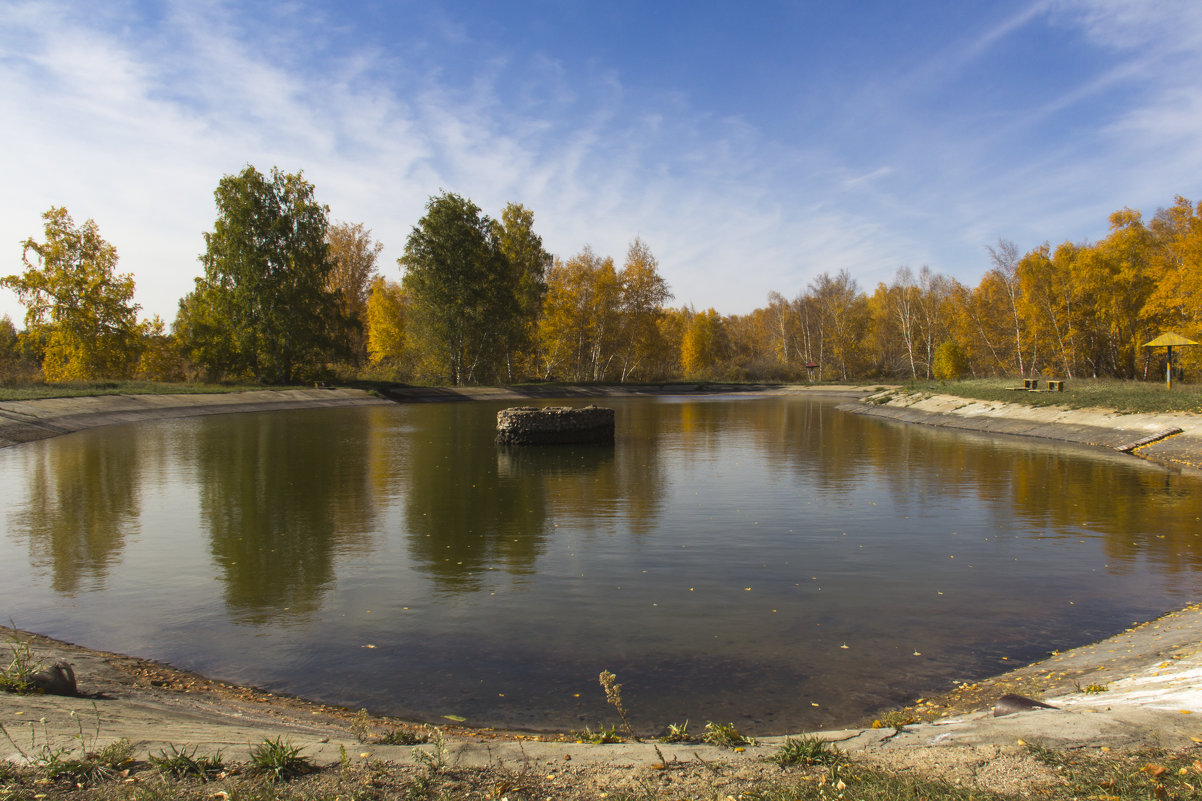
[0,0,1202,325]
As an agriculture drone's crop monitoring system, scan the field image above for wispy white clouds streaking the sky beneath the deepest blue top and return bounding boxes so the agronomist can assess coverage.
[0,0,1202,327]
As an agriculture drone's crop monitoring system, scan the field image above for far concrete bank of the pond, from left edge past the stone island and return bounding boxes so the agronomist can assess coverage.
[0,384,873,447]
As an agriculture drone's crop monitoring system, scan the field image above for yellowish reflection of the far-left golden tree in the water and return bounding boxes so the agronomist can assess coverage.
[10,428,144,595]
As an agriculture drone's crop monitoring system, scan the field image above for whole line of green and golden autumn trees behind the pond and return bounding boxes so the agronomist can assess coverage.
[0,166,1202,385]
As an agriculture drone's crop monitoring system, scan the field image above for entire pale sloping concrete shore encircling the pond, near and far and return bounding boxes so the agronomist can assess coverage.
[0,387,1202,789]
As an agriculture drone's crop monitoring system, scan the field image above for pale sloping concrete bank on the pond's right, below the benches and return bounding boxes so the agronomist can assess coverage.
[839,392,1202,471]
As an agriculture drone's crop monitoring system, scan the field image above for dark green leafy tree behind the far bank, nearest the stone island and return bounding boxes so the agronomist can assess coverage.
[398,192,522,385]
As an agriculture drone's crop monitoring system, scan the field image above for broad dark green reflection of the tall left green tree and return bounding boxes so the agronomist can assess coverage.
[196,411,374,623]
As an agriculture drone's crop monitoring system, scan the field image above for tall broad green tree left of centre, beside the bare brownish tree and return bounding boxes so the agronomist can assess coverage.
[175,166,346,384]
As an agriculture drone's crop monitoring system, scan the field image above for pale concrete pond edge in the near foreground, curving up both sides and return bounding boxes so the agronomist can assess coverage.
[0,605,1202,767]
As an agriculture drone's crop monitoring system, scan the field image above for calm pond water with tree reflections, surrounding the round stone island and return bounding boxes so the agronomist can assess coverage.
[0,397,1202,734]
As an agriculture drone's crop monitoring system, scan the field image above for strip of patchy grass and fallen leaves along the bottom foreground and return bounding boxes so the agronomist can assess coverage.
[0,738,1202,801]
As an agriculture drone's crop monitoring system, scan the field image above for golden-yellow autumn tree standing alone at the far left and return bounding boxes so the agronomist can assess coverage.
[0,207,142,381]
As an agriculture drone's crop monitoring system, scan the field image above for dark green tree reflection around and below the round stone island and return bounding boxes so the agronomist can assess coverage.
[405,404,664,592]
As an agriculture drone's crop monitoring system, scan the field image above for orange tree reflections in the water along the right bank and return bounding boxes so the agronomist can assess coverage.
[760,403,1202,574]
